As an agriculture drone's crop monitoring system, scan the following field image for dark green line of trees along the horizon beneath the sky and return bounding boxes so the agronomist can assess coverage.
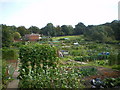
[1,20,120,47]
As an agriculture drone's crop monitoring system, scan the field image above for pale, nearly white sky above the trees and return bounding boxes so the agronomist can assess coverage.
[0,0,119,28]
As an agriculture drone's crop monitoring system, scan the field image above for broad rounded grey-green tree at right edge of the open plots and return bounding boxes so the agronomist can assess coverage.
[84,25,114,42]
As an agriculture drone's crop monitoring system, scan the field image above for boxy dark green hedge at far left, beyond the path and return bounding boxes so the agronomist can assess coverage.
[2,48,18,60]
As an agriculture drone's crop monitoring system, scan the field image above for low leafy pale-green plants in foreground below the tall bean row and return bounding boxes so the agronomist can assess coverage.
[20,67,84,88]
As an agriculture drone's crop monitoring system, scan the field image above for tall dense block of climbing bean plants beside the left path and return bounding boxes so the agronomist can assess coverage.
[20,44,58,76]
